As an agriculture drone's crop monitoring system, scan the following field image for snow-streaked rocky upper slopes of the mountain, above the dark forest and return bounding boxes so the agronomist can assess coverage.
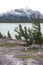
[0,9,43,19]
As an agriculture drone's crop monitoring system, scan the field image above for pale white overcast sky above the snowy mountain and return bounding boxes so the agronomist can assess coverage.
[0,0,43,14]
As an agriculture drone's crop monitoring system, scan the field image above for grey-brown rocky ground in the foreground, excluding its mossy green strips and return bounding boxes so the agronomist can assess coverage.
[0,47,43,65]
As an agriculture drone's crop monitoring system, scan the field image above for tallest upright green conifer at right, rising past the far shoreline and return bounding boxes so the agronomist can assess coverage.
[33,17,42,45]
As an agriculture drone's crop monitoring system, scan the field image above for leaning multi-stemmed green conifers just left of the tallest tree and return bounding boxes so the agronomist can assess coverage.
[14,24,32,45]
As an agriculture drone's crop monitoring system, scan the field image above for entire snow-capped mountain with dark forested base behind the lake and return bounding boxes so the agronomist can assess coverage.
[0,9,43,23]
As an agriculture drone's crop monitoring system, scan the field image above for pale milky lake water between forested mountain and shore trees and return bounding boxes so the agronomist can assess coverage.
[0,23,43,38]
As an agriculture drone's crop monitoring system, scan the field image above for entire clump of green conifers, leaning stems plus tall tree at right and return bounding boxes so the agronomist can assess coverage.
[14,16,43,46]
